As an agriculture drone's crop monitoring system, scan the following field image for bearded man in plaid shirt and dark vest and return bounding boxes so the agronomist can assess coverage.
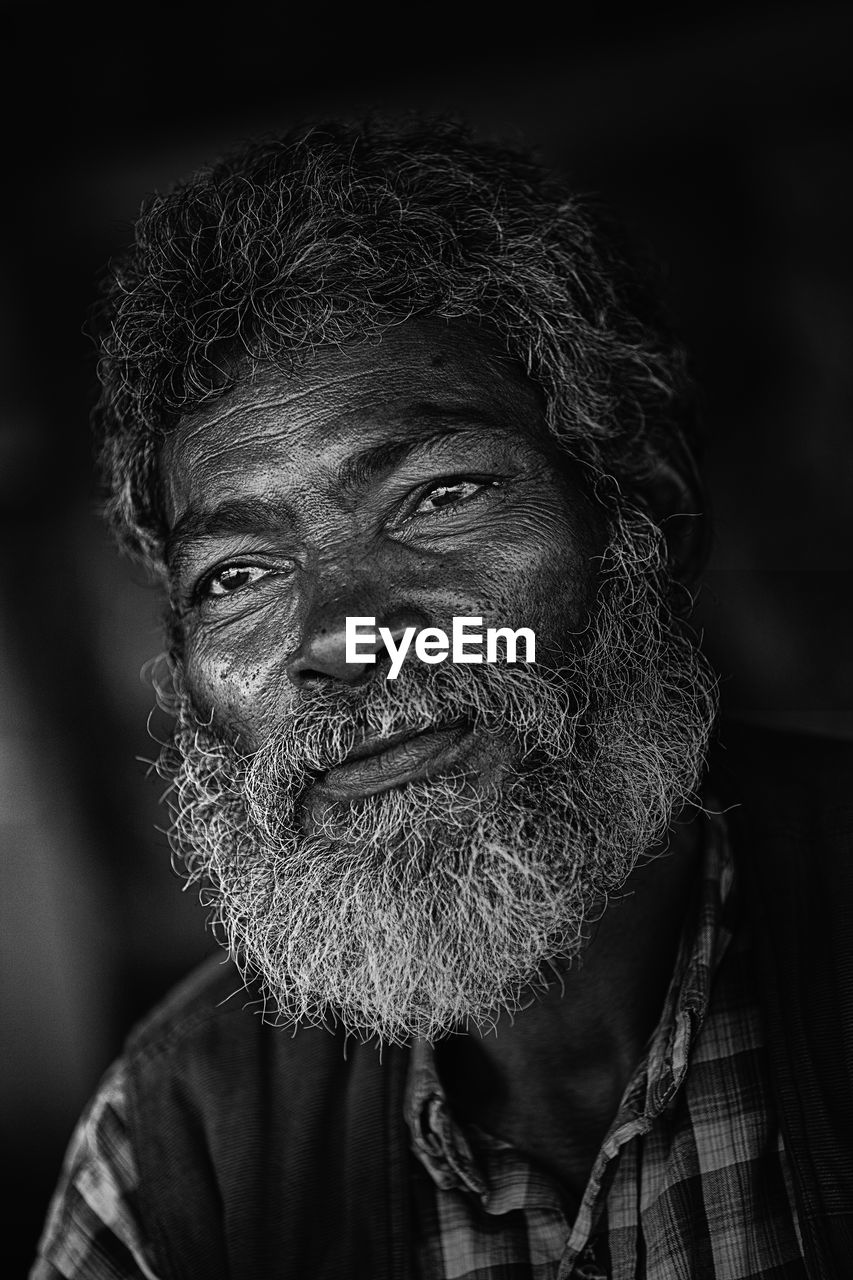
[33,115,853,1280]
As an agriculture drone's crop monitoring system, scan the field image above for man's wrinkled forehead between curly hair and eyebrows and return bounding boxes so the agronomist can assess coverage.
[160,321,544,524]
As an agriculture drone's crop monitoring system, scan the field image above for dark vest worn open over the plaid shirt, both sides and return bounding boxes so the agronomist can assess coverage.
[127,726,853,1280]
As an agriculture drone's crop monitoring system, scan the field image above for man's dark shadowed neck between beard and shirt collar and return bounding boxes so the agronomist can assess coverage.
[437,814,702,1192]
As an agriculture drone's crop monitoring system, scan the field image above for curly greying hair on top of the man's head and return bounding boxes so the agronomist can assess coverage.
[96,119,697,564]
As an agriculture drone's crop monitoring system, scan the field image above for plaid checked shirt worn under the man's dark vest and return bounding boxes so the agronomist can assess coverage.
[31,817,806,1280]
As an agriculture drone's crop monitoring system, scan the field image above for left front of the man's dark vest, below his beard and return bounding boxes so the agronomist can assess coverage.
[118,960,406,1277]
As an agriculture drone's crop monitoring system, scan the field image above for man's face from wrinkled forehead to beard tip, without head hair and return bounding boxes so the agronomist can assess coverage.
[161,323,710,1039]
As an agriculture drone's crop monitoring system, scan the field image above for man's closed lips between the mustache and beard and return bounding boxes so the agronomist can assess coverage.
[313,723,474,800]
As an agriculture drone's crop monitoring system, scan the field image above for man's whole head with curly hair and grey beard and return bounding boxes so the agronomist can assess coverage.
[101,115,713,1041]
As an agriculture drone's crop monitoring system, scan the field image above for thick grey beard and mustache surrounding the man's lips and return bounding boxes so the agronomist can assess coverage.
[160,504,716,1043]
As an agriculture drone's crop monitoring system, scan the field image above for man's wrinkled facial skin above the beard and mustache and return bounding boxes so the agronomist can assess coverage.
[163,324,605,752]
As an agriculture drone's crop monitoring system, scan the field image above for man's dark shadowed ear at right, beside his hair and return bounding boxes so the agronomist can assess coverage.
[627,448,711,590]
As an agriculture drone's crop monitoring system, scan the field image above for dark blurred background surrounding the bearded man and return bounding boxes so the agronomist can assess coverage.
[0,0,853,1275]
